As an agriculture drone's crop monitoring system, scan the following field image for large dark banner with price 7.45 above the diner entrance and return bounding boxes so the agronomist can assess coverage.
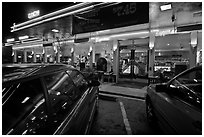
[72,2,149,34]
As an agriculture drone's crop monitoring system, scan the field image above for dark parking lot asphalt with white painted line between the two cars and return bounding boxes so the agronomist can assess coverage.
[90,95,163,135]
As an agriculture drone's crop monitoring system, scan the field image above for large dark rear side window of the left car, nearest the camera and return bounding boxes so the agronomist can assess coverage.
[2,79,49,135]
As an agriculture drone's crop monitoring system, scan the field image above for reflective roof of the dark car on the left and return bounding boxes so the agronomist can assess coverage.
[2,64,75,83]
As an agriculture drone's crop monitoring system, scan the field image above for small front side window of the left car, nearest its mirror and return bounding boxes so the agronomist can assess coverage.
[67,70,88,94]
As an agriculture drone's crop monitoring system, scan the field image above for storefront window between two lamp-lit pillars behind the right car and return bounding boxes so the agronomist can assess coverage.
[154,34,191,79]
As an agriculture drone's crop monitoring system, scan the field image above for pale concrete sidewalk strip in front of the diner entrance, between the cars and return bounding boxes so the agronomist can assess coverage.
[99,82,147,99]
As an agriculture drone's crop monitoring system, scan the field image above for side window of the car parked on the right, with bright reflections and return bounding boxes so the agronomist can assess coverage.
[170,69,202,108]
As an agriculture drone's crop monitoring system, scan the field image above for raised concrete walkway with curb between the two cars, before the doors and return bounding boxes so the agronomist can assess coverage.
[99,83,147,99]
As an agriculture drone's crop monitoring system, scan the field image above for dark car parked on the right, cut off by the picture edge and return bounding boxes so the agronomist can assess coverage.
[146,66,202,135]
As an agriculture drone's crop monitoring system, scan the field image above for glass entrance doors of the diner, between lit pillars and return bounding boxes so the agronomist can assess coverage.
[119,44,148,79]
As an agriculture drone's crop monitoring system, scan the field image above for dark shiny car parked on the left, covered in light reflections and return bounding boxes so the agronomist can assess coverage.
[2,64,100,135]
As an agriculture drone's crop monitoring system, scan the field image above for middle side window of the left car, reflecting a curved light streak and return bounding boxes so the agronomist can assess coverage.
[44,72,78,123]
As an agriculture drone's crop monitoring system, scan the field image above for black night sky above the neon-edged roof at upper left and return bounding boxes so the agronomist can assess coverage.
[2,2,77,42]
